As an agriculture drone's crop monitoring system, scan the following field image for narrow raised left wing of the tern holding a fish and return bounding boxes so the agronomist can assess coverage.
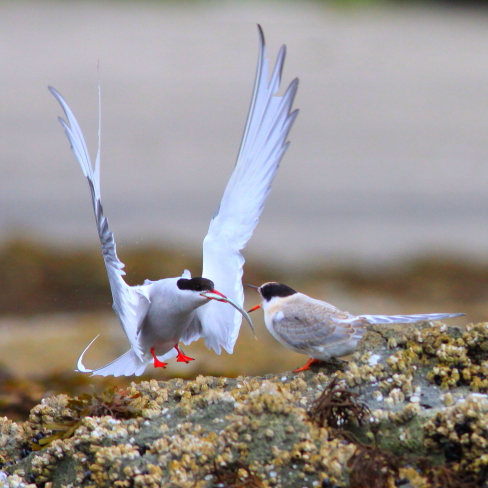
[49,87,149,360]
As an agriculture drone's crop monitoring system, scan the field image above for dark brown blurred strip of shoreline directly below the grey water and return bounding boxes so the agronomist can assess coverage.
[0,239,482,320]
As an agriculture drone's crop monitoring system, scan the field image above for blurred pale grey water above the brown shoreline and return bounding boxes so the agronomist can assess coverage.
[0,1,488,264]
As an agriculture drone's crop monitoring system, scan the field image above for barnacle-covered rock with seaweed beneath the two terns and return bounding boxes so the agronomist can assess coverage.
[0,324,488,488]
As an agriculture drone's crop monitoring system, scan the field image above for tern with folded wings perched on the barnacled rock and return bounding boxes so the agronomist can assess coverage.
[247,282,465,373]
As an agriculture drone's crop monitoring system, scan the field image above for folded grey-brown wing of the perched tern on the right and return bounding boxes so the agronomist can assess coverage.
[273,303,356,352]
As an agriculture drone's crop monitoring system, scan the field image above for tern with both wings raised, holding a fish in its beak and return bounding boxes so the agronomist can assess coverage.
[49,26,298,376]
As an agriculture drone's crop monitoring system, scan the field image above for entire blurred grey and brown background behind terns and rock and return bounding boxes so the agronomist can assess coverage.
[0,0,488,416]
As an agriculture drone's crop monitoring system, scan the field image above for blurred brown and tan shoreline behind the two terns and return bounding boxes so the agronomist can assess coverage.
[0,240,480,384]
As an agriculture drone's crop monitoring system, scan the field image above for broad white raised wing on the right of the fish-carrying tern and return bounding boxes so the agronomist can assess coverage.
[197,26,298,354]
